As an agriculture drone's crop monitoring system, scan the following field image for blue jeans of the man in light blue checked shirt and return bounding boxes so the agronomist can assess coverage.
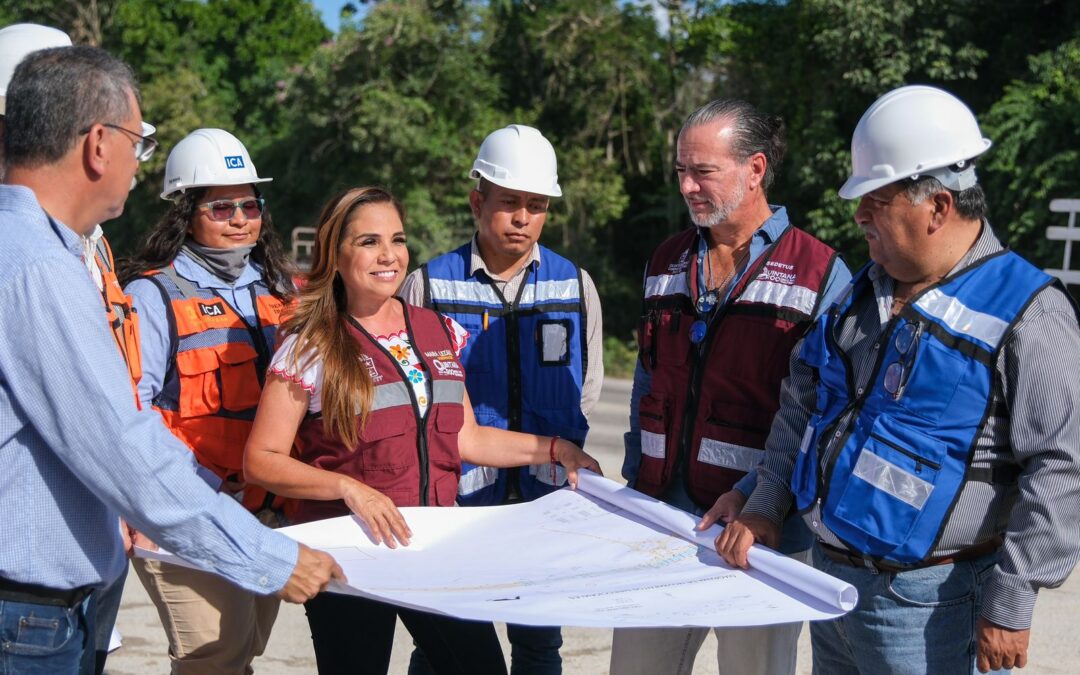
[0,598,94,675]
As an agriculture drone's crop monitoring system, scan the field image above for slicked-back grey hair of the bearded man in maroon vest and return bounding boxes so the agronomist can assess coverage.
[679,98,787,190]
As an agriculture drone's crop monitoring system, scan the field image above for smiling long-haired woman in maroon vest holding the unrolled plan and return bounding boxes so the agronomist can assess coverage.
[244,188,599,674]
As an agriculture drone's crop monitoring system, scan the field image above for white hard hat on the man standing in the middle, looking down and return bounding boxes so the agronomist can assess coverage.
[469,124,563,197]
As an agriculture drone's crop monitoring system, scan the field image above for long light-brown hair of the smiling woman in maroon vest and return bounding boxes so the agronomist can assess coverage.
[281,187,405,447]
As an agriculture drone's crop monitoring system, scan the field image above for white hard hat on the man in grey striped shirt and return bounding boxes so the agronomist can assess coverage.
[840,85,990,199]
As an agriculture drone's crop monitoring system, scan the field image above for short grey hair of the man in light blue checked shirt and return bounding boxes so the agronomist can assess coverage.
[3,46,139,167]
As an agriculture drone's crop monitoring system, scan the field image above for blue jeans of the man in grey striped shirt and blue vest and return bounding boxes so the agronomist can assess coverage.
[810,545,998,675]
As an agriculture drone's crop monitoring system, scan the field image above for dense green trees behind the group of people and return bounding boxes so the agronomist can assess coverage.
[0,0,1080,372]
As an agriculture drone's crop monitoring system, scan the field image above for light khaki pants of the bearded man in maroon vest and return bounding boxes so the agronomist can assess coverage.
[611,551,810,675]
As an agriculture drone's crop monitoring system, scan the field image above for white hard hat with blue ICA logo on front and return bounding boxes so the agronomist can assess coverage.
[161,129,273,199]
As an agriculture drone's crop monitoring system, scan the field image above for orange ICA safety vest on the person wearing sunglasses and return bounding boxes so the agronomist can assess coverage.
[147,266,285,513]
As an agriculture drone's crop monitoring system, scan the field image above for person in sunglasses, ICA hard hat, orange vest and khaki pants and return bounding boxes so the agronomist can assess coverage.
[120,129,293,674]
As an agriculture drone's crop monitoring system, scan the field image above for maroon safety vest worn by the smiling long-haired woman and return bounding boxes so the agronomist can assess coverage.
[288,305,465,523]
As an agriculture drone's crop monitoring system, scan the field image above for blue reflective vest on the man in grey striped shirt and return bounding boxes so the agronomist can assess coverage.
[792,252,1053,565]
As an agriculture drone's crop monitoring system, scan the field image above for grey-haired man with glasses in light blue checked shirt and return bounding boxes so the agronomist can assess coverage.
[0,46,342,674]
